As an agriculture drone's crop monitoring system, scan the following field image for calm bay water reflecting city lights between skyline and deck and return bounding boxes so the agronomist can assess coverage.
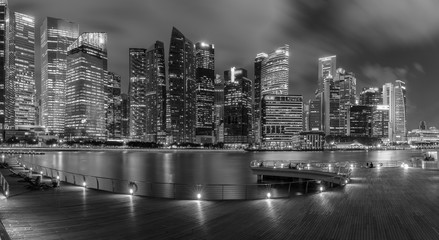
[23,150,422,184]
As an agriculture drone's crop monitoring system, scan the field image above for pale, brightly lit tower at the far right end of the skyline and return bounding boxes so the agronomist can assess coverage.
[383,80,407,142]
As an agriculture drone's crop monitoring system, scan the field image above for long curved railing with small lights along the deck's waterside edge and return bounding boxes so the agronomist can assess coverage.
[12,159,336,200]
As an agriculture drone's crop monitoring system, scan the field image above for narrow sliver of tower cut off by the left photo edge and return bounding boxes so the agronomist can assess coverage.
[0,0,11,129]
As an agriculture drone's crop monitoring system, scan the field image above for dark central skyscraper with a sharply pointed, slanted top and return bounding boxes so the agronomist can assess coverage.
[167,27,196,143]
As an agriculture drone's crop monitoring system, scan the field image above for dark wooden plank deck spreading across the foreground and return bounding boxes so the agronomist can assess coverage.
[0,165,439,240]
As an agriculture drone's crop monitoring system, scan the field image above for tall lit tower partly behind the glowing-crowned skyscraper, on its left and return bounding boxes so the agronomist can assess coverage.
[40,17,79,134]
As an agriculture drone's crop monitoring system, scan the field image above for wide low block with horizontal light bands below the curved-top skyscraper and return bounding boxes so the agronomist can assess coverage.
[261,94,303,149]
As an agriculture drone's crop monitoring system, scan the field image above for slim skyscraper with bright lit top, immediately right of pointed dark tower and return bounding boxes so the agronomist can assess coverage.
[195,42,215,143]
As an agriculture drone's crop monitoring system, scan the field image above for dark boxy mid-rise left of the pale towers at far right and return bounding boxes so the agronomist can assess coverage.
[348,105,373,137]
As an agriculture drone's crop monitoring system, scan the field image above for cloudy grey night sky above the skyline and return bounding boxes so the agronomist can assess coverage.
[9,0,439,130]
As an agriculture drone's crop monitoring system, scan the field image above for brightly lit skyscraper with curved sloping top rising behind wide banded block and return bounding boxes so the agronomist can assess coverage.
[261,45,290,96]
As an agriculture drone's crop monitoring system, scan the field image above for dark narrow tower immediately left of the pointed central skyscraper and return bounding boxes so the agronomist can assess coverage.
[145,41,166,144]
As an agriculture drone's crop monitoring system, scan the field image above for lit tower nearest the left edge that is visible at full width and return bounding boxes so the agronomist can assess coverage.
[6,12,36,127]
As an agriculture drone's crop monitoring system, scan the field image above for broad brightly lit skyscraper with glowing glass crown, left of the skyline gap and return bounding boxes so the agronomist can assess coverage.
[65,33,108,140]
